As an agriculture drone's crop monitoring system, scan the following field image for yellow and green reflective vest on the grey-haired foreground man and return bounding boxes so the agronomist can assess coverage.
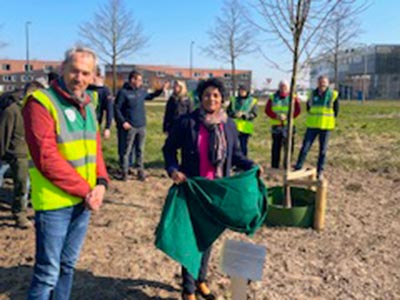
[29,88,97,210]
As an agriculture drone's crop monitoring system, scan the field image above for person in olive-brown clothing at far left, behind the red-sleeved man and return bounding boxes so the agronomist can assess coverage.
[0,93,32,229]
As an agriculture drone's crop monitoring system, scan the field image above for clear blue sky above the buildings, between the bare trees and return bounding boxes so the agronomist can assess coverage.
[0,0,400,87]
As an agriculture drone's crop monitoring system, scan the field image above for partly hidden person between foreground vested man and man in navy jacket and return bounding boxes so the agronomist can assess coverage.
[88,67,114,139]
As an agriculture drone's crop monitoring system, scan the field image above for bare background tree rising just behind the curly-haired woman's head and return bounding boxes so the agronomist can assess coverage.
[202,0,256,95]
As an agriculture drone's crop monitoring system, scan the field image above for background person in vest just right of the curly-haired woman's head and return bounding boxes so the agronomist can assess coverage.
[227,85,258,156]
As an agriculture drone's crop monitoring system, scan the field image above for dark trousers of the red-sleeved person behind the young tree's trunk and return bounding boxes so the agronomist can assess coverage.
[271,126,296,169]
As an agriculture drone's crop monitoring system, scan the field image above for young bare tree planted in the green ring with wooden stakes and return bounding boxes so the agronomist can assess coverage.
[247,0,349,207]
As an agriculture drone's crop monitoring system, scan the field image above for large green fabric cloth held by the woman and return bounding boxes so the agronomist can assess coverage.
[155,168,267,279]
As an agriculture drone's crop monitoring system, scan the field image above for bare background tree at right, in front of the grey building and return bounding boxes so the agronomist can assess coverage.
[320,1,370,88]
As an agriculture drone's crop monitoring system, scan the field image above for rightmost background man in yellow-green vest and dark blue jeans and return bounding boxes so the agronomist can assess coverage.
[295,76,339,180]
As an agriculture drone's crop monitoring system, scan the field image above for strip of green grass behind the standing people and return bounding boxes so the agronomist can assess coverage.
[103,101,400,173]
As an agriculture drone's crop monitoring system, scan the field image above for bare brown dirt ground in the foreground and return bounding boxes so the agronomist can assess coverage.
[0,169,400,300]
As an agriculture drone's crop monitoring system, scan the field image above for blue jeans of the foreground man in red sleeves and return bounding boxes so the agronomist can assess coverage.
[28,203,90,300]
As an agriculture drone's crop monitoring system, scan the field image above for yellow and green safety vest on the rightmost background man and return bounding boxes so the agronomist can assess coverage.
[306,89,338,130]
